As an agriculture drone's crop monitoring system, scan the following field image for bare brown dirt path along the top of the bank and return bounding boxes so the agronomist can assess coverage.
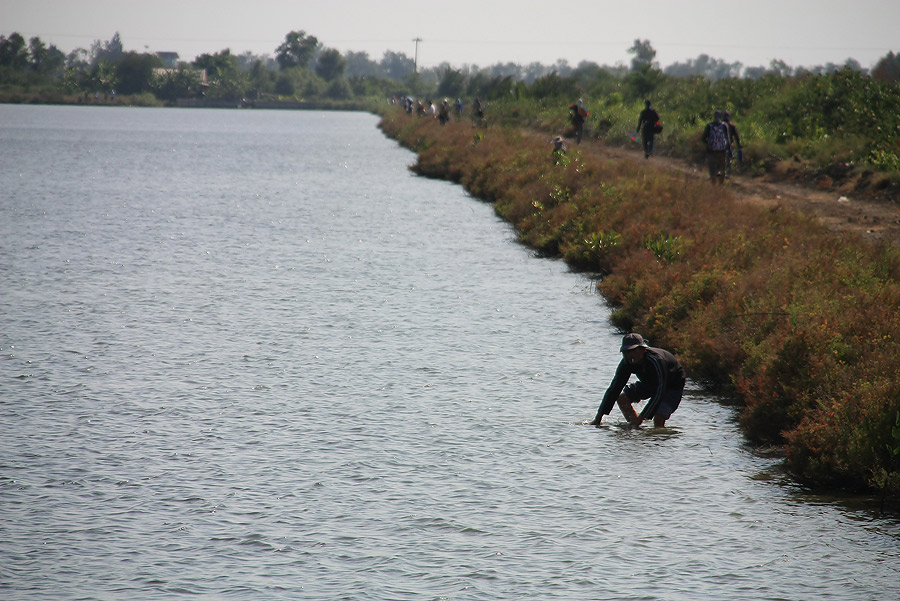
[584,139,900,244]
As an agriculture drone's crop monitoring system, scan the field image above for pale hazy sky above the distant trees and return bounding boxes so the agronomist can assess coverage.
[0,0,900,67]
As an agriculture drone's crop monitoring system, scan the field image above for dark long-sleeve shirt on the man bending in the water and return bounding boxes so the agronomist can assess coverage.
[597,347,685,419]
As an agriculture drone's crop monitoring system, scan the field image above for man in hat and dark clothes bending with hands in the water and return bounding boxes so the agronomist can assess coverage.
[590,333,686,428]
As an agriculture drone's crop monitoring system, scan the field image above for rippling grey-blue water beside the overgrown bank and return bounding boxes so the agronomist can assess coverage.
[0,106,900,601]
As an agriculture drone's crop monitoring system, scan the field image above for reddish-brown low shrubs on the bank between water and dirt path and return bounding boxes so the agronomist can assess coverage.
[381,109,900,495]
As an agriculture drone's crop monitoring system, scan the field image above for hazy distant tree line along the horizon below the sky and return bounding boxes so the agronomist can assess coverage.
[0,31,900,103]
